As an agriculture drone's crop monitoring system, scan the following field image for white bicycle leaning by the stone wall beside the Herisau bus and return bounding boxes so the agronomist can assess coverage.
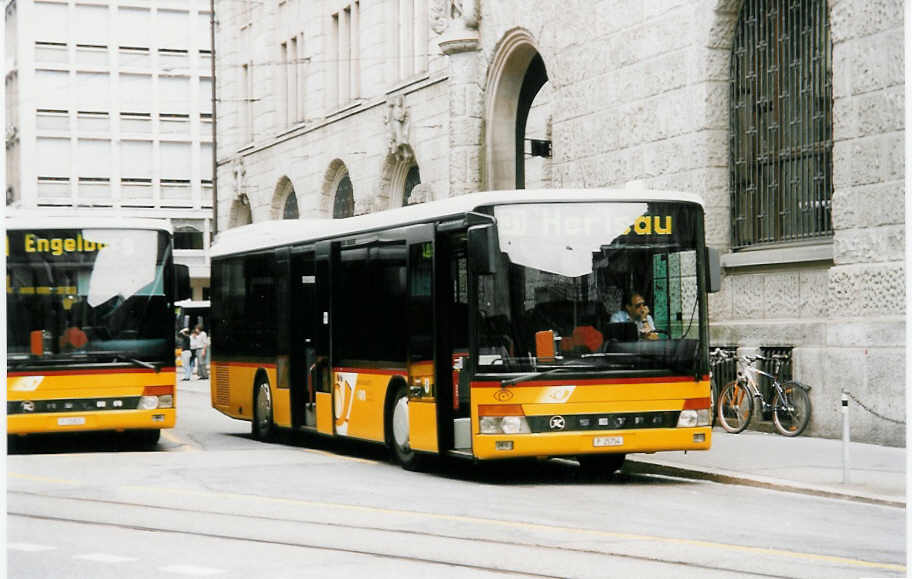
[713,349,811,436]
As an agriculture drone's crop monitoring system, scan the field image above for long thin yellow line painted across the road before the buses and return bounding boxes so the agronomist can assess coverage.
[128,486,906,571]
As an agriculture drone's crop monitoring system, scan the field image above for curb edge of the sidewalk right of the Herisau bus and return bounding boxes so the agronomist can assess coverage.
[623,458,906,509]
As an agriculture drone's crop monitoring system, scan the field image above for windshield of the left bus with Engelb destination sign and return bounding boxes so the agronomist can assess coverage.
[6,229,174,369]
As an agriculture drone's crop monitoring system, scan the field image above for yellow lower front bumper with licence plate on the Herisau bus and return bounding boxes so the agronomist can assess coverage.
[473,426,712,460]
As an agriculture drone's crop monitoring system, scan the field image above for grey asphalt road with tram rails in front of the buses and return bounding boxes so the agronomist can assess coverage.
[7,382,906,579]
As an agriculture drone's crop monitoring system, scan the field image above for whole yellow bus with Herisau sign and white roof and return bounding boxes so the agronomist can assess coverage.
[211,189,718,473]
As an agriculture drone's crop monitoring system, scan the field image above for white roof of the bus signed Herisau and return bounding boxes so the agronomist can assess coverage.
[209,186,703,257]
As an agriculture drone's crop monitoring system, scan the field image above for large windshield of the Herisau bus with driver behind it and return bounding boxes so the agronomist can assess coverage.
[477,202,705,374]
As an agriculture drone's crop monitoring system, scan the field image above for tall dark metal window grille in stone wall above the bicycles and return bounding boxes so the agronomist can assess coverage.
[729,0,833,249]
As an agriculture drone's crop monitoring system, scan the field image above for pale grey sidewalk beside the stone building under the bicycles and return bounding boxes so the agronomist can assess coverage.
[624,427,906,507]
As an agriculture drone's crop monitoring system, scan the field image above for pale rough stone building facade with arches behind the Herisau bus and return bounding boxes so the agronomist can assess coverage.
[216,0,906,445]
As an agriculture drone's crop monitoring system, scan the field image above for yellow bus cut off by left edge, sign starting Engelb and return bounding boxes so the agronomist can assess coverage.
[5,215,190,444]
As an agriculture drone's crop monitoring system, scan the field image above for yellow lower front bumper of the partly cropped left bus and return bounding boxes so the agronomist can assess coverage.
[6,408,177,434]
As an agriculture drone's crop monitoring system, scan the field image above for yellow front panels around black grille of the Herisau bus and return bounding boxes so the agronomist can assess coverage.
[472,380,712,459]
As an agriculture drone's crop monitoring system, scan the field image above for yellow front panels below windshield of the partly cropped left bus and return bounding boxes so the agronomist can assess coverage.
[6,369,177,434]
